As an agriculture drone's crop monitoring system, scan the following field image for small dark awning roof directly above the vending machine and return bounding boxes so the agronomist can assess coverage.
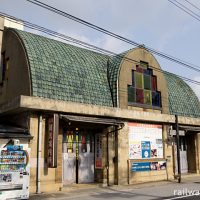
[0,124,33,139]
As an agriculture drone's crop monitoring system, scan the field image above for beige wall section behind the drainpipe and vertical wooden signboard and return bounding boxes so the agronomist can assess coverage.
[30,115,62,193]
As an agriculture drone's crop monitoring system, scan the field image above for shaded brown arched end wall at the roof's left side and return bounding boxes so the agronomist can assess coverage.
[0,31,31,104]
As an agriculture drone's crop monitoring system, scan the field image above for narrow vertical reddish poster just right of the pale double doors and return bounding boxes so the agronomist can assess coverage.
[95,134,103,169]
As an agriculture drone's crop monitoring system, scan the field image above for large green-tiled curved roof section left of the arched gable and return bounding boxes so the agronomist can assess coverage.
[14,30,113,106]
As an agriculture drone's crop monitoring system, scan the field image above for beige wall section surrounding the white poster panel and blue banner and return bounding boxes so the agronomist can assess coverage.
[118,123,174,184]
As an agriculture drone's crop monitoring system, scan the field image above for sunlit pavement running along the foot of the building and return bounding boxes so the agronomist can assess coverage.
[30,174,200,200]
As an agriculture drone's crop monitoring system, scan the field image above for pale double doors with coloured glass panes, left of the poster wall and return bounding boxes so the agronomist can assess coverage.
[63,128,94,184]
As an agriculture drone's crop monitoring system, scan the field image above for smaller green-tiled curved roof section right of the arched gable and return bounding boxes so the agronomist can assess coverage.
[165,73,200,117]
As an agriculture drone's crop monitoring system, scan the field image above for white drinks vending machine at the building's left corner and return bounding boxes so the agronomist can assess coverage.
[0,142,30,200]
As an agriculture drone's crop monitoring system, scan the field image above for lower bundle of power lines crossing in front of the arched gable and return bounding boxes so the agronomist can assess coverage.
[0,12,200,85]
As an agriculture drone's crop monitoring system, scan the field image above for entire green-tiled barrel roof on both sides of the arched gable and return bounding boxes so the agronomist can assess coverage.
[12,29,200,117]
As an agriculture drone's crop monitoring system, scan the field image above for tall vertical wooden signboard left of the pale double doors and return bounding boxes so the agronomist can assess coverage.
[47,115,59,168]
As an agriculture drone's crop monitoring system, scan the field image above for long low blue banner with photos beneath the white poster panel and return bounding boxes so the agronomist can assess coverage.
[131,161,166,172]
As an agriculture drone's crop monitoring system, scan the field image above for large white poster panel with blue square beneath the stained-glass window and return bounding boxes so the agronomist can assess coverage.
[128,123,163,159]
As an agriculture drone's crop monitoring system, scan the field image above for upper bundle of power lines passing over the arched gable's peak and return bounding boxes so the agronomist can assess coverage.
[26,0,200,72]
